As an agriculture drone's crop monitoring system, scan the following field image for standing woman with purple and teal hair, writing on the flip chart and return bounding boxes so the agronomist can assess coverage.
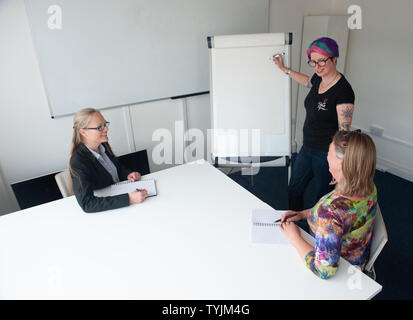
[273,37,354,211]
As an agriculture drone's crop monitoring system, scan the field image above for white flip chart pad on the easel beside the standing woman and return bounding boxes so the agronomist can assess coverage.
[210,33,291,159]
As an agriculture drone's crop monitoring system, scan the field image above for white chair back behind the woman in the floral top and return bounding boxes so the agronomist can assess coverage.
[364,204,388,280]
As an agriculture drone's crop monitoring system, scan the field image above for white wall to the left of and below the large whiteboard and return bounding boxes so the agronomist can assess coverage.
[0,0,210,213]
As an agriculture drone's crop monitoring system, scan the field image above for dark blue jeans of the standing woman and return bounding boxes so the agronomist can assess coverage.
[288,146,334,211]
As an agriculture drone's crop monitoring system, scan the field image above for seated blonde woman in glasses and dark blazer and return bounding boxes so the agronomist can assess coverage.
[69,108,147,212]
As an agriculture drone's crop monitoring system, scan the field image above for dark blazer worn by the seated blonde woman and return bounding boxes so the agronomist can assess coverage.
[70,143,131,213]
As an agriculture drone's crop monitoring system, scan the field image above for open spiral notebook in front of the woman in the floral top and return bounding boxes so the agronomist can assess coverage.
[251,209,289,244]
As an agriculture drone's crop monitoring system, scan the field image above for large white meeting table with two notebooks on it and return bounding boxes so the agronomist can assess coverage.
[0,163,381,300]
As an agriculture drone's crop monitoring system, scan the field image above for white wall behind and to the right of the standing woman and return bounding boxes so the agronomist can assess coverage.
[270,0,413,181]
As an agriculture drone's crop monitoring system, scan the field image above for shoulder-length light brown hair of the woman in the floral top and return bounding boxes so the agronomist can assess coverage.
[333,131,376,198]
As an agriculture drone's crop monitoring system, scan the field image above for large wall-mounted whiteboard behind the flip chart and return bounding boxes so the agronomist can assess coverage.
[25,0,269,117]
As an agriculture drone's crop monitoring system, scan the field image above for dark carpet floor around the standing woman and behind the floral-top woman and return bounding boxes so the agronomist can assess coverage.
[229,162,413,300]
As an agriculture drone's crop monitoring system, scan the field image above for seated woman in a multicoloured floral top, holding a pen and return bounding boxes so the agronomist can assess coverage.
[281,131,377,279]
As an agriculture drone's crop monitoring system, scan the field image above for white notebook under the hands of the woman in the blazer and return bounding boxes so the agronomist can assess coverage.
[93,179,157,197]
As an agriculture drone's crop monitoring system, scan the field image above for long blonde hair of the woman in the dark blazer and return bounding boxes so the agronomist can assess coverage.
[68,108,115,192]
